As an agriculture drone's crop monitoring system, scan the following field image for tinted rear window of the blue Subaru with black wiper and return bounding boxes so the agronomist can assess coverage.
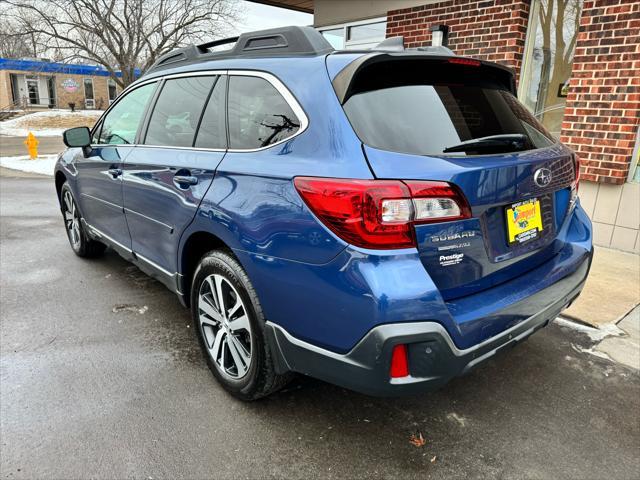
[343,60,555,156]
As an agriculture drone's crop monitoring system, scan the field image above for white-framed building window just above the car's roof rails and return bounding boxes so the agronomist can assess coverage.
[318,18,387,50]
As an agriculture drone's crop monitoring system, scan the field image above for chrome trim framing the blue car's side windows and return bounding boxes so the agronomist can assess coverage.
[91,69,309,153]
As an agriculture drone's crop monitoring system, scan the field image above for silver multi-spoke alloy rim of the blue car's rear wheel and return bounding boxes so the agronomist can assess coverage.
[198,274,251,380]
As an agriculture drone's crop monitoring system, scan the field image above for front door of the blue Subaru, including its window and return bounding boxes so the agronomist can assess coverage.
[77,83,156,253]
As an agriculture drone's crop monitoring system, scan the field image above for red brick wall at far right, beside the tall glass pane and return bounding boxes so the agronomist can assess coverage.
[561,0,640,184]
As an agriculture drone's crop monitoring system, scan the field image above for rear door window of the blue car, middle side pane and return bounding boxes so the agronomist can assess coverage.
[144,75,217,147]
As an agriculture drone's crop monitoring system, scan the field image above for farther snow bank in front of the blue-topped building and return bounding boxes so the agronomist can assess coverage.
[0,109,104,137]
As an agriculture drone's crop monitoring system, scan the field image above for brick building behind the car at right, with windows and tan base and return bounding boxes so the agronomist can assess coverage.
[252,0,640,252]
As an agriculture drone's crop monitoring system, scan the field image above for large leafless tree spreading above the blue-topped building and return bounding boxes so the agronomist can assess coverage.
[0,0,239,88]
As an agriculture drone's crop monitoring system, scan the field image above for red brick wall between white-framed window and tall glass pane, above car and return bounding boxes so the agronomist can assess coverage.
[387,0,530,81]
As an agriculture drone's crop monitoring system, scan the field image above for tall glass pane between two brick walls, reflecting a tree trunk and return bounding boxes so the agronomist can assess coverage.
[518,0,582,137]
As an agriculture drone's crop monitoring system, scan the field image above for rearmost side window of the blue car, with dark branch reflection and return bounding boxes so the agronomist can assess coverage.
[229,75,300,149]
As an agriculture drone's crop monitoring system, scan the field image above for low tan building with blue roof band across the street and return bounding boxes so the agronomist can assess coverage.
[0,58,126,109]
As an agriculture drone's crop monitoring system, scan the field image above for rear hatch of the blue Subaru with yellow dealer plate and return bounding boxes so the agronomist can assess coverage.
[330,54,576,300]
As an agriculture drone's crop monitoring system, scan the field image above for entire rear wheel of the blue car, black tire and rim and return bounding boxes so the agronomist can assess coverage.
[191,250,291,401]
